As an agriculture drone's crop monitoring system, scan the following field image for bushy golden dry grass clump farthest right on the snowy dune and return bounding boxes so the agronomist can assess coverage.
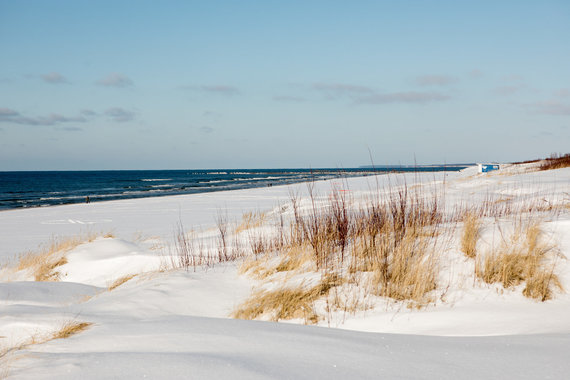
[475,221,563,301]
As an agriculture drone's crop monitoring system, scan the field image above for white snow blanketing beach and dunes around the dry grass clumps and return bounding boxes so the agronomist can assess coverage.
[0,166,570,379]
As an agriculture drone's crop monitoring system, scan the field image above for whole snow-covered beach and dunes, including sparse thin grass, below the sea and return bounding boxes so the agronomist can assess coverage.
[0,164,570,379]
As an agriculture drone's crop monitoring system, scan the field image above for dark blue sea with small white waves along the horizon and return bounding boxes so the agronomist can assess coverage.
[0,165,467,211]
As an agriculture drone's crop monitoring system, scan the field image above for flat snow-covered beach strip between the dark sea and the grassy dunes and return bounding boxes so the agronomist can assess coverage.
[0,171,461,260]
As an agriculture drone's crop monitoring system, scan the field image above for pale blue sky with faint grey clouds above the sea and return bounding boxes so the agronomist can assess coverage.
[0,0,570,170]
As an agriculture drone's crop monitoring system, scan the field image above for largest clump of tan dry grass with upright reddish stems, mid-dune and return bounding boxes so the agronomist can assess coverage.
[234,180,444,322]
